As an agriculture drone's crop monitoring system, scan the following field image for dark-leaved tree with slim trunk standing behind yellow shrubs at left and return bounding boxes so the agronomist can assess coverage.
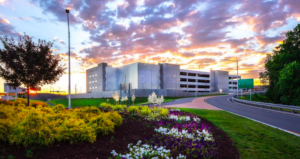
[0,35,66,105]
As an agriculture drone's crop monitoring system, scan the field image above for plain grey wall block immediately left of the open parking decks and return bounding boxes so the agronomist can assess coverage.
[159,63,180,89]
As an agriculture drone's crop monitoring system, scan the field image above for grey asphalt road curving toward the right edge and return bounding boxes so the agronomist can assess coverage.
[206,95,300,134]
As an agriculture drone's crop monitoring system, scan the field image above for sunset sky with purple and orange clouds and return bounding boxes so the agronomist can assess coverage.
[0,0,300,93]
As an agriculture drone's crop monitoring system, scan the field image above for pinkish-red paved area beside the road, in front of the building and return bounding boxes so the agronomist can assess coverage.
[163,96,221,110]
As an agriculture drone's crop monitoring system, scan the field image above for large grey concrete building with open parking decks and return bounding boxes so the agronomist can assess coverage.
[75,62,240,98]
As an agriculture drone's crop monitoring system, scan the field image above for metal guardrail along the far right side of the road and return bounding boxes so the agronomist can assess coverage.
[232,95,300,114]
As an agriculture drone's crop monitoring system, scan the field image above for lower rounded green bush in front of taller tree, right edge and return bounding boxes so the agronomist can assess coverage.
[277,61,300,105]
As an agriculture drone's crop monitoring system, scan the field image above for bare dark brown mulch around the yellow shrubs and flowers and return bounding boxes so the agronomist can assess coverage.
[0,113,239,159]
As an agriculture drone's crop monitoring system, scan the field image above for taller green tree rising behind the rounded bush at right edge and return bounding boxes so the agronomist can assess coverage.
[262,24,300,103]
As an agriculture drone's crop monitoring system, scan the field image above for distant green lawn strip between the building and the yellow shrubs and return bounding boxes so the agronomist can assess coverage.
[48,94,227,108]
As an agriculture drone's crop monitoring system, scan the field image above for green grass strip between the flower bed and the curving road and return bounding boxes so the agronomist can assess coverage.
[180,108,300,159]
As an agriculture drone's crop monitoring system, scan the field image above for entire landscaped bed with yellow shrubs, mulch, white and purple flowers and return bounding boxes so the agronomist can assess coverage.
[0,102,239,159]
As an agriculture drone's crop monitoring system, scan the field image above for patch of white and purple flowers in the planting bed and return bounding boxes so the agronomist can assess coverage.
[111,110,218,159]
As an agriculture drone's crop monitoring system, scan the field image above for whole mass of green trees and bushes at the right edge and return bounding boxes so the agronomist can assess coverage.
[260,24,300,105]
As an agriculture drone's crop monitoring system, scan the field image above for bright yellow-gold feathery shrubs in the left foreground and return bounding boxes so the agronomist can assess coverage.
[0,100,123,146]
